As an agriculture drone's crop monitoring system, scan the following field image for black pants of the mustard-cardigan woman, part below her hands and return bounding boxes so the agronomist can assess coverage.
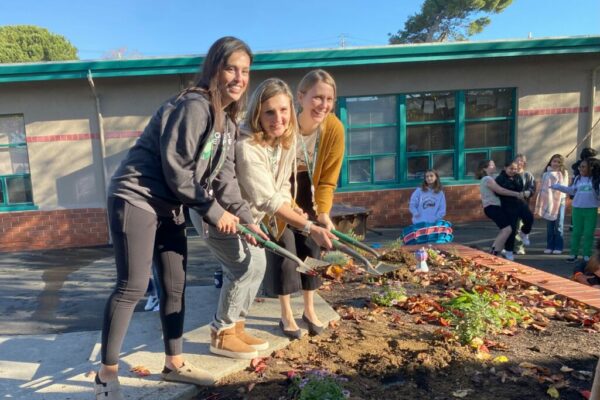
[267,228,321,296]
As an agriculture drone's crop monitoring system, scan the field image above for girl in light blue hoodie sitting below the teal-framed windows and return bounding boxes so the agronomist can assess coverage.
[408,169,446,224]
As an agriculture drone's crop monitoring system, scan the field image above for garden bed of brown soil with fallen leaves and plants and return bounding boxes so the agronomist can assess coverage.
[196,247,600,400]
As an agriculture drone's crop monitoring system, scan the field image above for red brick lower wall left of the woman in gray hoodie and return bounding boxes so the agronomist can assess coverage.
[0,208,108,252]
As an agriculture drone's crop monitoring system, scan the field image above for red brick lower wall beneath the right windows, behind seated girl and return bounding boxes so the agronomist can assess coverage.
[334,185,486,227]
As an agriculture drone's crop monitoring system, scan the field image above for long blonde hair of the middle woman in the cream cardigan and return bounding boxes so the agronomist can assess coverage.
[244,78,298,150]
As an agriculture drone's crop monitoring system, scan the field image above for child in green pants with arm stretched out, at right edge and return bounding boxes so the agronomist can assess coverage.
[551,158,600,262]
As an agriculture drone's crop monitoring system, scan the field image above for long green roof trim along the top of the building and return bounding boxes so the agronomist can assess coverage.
[0,36,600,83]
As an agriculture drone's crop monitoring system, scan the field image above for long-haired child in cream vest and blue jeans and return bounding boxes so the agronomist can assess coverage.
[535,154,569,254]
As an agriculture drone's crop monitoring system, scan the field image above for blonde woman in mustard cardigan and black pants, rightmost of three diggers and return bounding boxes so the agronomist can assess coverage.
[268,69,344,337]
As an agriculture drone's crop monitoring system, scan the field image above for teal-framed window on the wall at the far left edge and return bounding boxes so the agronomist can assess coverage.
[0,115,33,211]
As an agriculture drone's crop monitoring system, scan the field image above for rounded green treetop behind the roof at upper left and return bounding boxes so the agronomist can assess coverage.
[0,25,78,63]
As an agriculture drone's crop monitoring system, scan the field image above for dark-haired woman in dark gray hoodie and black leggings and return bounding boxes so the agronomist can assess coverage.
[94,37,260,400]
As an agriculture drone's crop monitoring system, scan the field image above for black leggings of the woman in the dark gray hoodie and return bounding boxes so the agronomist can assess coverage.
[101,197,187,365]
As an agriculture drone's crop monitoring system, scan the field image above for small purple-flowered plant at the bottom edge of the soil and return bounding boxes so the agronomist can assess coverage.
[288,370,350,400]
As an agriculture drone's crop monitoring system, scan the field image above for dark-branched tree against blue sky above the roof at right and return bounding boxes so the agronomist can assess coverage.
[389,0,512,44]
